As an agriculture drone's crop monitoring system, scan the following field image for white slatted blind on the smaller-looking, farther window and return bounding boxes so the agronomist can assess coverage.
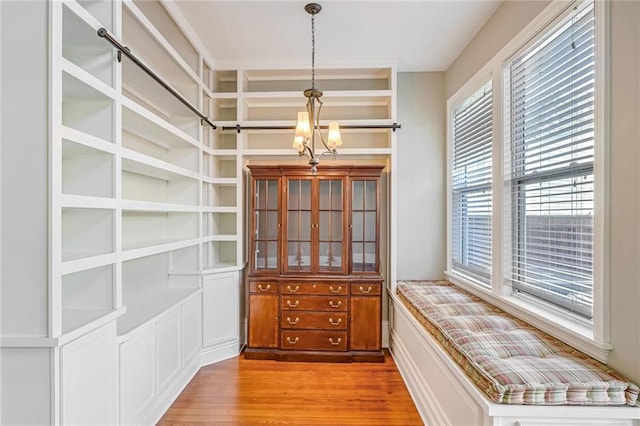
[451,81,493,284]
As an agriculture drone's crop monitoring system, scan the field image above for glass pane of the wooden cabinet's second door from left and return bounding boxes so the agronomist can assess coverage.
[285,179,313,272]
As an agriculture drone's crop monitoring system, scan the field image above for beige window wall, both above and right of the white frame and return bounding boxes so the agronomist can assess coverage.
[444,0,640,383]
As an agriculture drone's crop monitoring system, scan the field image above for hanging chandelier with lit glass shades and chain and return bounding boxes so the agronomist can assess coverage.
[293,3,342,173]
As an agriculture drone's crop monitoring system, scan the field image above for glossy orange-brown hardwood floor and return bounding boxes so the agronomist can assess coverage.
[159,353,422,426]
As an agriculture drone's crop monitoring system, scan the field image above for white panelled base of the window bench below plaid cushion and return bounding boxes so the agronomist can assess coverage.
[389,295,640,426]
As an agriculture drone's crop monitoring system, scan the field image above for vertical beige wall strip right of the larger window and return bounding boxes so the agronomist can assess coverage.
[609,0,640,383]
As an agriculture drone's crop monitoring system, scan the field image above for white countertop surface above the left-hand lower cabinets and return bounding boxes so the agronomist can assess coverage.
[117,288,202,341]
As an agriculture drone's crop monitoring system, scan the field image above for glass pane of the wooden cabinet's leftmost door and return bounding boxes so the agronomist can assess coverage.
[253,179,279,271]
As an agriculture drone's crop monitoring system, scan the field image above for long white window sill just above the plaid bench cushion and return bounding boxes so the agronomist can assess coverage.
[445,271,613,363]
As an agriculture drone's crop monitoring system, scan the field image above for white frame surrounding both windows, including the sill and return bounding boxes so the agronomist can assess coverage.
[445,0,612,362]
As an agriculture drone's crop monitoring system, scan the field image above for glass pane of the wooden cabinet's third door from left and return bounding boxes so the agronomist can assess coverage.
[318,179,346,272]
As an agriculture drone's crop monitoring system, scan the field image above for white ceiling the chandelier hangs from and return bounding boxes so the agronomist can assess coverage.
[173,0,501,71]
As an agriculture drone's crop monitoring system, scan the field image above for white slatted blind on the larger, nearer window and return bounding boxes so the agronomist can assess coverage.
[507,2,595,318]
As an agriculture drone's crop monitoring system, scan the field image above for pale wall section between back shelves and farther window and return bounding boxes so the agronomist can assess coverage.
[395,72,446,280]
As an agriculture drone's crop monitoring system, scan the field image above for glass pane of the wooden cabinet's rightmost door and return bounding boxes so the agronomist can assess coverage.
[351,179,379,273]
